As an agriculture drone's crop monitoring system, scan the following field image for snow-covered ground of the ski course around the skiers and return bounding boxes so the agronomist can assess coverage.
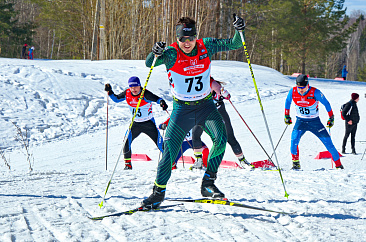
[0,58,366,241]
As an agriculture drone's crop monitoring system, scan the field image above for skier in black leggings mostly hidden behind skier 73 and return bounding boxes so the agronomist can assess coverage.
[192,77,253,169]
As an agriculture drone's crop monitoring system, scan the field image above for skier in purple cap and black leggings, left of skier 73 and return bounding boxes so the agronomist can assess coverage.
[104,76,168,170]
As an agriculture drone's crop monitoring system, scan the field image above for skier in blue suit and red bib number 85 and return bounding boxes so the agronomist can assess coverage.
[285,75,343,170]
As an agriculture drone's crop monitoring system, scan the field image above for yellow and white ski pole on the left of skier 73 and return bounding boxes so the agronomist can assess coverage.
[99,55,158,208]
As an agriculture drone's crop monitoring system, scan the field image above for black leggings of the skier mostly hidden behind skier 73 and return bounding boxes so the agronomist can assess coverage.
[192,103,243,155]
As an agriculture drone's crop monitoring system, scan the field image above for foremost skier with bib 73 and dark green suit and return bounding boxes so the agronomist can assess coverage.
[141,16,245,208]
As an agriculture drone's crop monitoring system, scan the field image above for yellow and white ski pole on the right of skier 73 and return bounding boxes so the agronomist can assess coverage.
[234,14,289,199]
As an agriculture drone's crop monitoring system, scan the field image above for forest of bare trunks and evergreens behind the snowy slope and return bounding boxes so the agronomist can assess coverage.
[0,0,366,81]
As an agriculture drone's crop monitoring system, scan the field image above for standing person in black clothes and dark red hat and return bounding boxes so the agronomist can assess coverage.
[342,93,360,155]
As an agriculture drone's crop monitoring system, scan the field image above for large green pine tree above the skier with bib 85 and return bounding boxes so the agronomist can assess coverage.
[249,0,358,73]
